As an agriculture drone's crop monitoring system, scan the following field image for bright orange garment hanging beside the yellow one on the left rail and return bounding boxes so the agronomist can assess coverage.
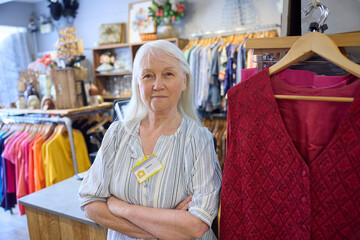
[33,137,46,191]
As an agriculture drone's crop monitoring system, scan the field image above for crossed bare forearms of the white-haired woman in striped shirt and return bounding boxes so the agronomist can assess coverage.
[85,196,209,239]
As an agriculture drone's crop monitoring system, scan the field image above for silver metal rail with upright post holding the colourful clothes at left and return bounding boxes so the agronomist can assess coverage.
[0,116,82,180]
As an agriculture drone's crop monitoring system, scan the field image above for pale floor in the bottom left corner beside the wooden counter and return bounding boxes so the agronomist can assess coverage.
[0,206,30,240]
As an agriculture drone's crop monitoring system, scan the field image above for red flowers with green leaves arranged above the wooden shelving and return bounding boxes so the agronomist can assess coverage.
[149,0,185,26]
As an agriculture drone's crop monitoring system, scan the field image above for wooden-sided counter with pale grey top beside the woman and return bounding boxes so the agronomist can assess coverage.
[19,173,107,240]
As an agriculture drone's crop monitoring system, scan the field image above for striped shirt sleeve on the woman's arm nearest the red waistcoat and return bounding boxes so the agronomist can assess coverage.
[189,127,222,227]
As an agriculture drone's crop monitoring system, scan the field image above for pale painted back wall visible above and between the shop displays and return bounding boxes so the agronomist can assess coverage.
[0,0,360,61]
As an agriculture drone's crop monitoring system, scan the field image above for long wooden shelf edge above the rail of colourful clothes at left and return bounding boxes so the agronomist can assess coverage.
[0,102,113,116]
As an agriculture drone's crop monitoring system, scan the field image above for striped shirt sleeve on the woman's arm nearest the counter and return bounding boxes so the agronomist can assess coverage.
[79,122,117,209]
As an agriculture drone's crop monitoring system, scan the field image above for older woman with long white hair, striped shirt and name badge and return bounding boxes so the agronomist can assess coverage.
[79,40,221,240]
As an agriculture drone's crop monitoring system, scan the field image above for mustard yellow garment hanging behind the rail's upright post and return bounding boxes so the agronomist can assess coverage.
[44,130,91,187]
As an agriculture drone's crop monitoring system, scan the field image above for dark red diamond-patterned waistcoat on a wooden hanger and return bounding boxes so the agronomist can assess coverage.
[220,69,360,240]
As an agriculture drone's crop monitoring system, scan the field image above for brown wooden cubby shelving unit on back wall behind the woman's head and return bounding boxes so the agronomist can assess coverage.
[93,38,188,101]
